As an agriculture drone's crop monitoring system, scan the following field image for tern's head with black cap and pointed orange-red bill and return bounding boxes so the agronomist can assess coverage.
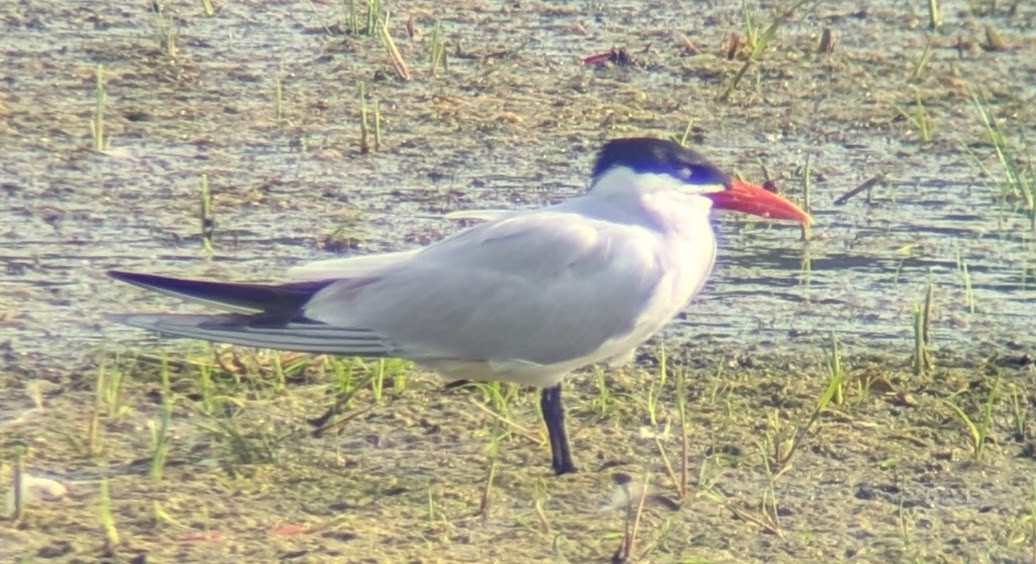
[592,137,812,224]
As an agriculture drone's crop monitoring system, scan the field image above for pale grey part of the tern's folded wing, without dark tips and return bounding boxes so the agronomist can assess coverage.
[303,212,667,364]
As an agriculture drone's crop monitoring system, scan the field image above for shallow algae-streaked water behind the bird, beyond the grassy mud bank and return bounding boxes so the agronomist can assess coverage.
[0,3,1036,369]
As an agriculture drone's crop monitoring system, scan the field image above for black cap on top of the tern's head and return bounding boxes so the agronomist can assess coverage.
[594,137,730,186]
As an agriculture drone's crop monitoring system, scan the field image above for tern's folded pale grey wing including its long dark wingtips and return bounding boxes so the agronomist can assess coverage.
[112,212,668,365]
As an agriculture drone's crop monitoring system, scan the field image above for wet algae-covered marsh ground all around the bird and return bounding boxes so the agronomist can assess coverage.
[0,1,1036,561]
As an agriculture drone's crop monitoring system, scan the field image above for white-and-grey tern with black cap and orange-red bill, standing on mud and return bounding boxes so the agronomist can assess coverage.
[109,137,812,475]
